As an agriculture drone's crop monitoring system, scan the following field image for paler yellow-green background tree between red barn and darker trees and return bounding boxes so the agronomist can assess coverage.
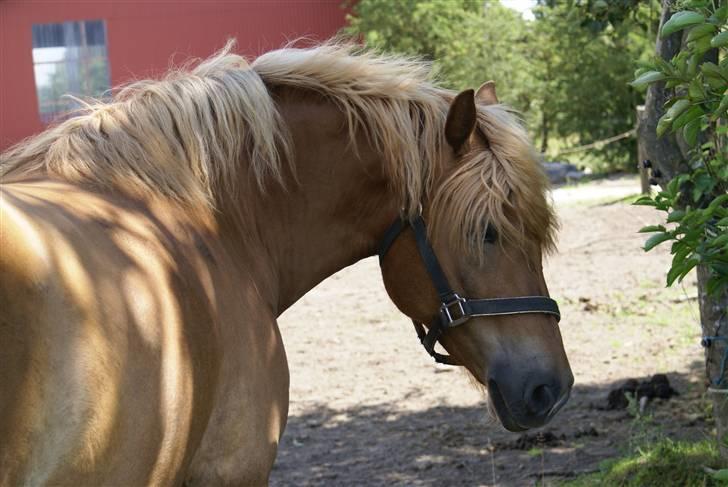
[346,0,528,94]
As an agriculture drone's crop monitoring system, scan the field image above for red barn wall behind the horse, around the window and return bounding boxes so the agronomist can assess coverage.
[0,0,345,151]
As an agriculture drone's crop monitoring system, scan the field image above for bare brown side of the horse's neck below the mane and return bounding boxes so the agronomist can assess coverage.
[230,92,397,314]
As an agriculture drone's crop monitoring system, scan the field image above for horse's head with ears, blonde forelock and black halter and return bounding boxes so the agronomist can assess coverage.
[380,84,574,431]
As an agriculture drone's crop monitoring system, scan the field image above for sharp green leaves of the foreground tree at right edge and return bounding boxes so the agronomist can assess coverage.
[632,0,728,293]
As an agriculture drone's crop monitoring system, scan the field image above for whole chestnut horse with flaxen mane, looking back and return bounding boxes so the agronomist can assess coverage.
[0,44,573,485]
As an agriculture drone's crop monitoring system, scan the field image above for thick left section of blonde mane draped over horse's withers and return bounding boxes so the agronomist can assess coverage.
[0,44,291,207]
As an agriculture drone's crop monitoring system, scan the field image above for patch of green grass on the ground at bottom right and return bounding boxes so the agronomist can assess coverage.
[561,439,728,487]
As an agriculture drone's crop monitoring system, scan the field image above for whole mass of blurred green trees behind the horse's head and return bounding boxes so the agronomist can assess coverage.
[347,0,660,172]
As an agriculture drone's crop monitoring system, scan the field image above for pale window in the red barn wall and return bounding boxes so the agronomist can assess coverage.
[33,20,109,123]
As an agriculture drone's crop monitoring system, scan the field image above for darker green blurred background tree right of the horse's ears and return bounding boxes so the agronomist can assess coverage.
[533,0,657,170]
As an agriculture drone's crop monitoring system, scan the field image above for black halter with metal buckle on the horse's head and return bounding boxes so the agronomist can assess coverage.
[379,215,561,365]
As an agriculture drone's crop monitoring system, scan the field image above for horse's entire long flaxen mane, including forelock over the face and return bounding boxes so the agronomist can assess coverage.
[0,42,555,255]
